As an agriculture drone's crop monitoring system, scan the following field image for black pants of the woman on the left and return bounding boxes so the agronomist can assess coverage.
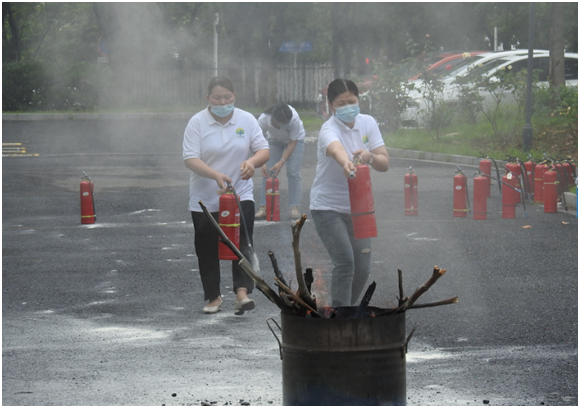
[191,201,254,301]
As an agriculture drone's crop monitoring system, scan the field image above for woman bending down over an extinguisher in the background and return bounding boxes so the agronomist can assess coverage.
[256,103,306,219]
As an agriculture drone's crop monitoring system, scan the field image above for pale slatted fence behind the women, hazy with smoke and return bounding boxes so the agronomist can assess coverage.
[111,64,334,105]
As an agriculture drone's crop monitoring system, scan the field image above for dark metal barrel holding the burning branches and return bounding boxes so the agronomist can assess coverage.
[280,307,407,406]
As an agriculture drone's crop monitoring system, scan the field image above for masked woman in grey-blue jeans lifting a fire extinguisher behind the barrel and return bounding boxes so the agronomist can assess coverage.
[310,79,389,306]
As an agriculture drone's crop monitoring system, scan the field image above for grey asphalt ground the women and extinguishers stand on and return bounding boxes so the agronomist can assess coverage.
[2,118,578,405]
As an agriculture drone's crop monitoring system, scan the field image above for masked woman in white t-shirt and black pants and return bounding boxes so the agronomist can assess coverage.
[183,77,270,315]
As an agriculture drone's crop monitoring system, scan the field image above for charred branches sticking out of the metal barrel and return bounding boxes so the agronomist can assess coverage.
[199,201,459,318]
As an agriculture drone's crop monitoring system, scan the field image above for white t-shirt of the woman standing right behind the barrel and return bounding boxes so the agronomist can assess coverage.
[310,113,385,214]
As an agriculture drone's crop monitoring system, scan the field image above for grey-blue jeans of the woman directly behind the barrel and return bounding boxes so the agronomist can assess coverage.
[311,210,371,307]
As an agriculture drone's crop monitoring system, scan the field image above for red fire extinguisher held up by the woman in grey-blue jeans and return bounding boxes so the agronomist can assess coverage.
[348,164,377,239]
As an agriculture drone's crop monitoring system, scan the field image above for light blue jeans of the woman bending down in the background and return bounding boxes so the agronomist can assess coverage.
[260,139,304,207]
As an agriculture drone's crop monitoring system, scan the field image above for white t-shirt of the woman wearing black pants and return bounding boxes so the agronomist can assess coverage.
[183,108,269,212]
